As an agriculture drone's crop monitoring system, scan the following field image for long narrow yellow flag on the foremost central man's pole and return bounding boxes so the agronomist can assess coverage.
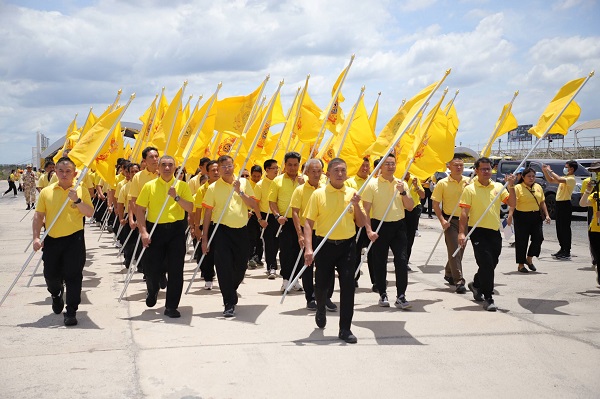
[366,82,438,155]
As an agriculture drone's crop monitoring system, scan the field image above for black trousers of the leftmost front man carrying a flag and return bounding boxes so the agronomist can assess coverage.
[42,230,85,315]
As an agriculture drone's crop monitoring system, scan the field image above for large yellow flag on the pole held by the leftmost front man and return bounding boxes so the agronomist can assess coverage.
[69,107,123,168]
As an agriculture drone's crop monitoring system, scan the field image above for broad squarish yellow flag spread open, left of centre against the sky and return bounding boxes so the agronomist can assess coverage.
[215,81,266,134]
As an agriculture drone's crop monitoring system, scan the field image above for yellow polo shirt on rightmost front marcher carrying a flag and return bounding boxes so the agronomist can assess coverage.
[460,179,509,230]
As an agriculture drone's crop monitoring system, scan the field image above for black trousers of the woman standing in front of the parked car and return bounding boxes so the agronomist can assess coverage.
[513,209,544,264]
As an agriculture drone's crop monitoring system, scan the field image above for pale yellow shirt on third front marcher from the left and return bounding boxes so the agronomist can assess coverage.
[202,179,254,229]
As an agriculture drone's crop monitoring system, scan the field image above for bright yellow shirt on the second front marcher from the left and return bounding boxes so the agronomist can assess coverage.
[136,177,192,224]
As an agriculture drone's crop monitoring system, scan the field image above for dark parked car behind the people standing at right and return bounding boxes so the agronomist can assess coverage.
[496,159,590,219]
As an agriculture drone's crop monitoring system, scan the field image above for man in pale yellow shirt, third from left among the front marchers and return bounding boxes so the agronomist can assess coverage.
[202,155,267,317]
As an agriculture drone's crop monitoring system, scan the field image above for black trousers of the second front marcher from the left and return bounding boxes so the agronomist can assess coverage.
[142,219,187,309]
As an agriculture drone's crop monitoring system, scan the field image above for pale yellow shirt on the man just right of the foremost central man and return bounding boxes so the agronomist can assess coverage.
[361,176,404,222]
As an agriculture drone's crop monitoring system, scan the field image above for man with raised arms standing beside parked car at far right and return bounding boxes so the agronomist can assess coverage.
[542,161,579,260]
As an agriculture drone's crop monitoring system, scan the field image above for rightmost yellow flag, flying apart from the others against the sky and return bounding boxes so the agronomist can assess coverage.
[529,78,586,138]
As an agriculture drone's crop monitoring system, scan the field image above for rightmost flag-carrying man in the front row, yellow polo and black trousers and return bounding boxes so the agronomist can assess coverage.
[458,157,517,312]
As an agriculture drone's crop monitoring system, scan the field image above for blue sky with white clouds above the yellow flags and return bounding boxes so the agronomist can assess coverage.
[0,0,600,163]
